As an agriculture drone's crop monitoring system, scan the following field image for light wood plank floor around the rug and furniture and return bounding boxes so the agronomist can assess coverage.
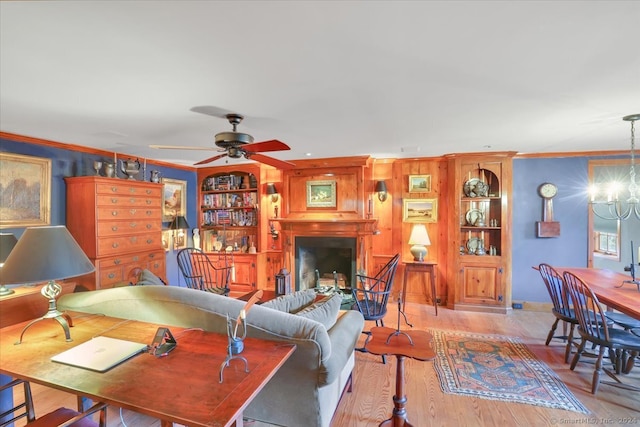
[11,303,640,427]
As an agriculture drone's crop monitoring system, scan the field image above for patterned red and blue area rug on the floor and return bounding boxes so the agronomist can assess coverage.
[429,329,589,414]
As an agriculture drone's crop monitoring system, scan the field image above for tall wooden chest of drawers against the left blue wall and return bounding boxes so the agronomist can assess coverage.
[65,176,166,289]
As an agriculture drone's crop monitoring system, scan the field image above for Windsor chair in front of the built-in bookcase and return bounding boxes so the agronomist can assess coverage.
[177,248,232,296]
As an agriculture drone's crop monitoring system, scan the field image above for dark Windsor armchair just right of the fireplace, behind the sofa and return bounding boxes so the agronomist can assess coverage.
[351,254,400,363]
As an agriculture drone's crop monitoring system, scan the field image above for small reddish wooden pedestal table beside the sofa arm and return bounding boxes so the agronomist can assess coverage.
[364,327,436,427]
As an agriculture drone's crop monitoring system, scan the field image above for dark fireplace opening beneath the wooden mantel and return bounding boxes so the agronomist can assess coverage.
[295,237,356,290]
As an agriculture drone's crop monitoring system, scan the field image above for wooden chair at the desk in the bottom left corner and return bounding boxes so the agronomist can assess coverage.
[0,379,107,427]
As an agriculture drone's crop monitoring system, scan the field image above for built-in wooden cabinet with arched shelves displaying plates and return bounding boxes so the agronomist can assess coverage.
[447,152,515,313]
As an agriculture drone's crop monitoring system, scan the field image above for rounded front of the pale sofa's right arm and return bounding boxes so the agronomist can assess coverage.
[318,310,364,385]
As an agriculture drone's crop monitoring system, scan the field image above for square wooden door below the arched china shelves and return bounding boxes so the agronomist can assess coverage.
[460,265,504,305]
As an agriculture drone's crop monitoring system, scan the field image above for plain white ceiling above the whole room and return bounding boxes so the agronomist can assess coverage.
[0,0,640,165]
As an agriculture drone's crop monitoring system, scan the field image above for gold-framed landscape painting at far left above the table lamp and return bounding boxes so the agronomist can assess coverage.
[0,153,51,227]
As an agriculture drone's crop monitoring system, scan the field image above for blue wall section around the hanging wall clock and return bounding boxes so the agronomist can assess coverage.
[512,157,589,302]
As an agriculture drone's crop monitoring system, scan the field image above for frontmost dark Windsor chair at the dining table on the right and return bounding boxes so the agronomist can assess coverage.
[563,271,640,394]
